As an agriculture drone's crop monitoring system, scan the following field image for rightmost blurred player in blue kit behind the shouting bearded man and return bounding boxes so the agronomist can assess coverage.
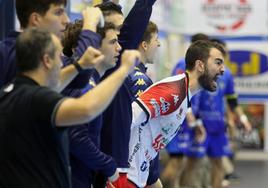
[182,39,251,188]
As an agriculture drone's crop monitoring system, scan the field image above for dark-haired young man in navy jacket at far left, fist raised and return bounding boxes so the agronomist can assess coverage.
[0,0,102,91]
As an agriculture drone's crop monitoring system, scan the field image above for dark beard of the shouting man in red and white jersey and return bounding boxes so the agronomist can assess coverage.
[198,68,217,91]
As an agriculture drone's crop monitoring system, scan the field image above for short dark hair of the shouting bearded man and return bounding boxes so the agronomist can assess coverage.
[185,40,226,71]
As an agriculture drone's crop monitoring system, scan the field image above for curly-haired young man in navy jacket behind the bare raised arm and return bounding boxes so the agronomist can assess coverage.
[63,20,123,188]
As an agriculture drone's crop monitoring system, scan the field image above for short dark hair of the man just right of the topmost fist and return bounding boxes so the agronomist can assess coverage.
[95,1,123,17]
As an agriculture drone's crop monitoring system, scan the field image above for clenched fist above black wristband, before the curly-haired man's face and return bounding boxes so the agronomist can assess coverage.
[78,47,104,69]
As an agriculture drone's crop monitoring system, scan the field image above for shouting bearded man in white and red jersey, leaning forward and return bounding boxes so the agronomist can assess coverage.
[128,41,225,187]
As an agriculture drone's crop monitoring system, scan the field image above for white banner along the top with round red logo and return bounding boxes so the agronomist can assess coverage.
[120,0,268,36]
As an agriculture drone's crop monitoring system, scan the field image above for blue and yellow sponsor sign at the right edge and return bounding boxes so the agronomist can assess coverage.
[226,50,268,98]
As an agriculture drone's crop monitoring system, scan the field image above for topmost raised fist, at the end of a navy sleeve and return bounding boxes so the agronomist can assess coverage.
[82,7,103,32]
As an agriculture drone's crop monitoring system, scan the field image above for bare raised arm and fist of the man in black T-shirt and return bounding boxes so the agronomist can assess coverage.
[55,50,140,126]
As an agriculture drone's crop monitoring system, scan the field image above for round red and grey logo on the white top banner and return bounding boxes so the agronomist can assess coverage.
[201,0,252,32]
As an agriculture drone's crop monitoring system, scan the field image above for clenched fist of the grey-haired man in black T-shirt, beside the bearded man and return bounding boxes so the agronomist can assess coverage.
[120,50,140,73]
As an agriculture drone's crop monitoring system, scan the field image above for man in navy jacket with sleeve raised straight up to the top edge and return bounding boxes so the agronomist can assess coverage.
[91,0,159,187]
